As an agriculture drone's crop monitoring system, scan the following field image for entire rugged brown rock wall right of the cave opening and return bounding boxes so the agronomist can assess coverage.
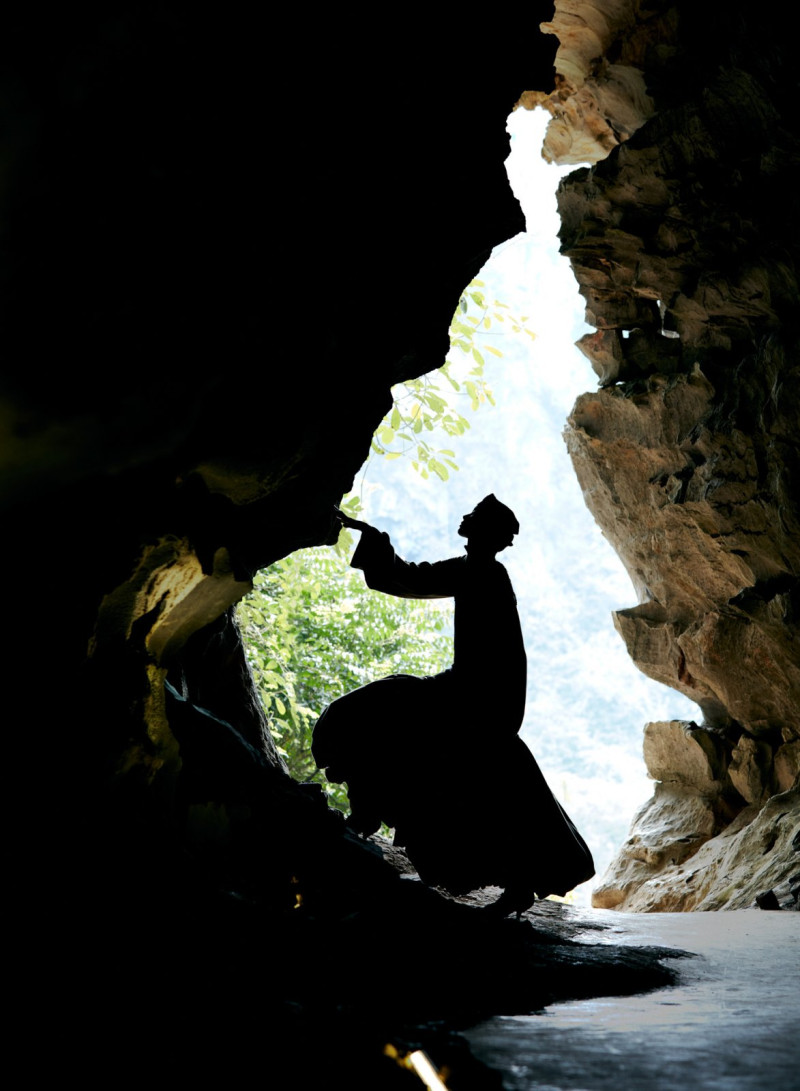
[523,0,800,910]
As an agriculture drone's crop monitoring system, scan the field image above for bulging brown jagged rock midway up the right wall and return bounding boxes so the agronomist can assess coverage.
[566,369,800,735]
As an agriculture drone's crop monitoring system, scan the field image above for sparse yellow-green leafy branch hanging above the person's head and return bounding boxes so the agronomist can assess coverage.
[372,280,536,481]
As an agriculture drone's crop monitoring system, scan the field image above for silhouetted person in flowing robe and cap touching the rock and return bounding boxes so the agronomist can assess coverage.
[313,495,594,912]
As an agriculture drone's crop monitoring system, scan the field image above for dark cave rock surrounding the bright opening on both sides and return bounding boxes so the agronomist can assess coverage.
[0,0,800,1088]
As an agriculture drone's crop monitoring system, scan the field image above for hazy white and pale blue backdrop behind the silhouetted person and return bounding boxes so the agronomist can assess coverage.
[347,110,698,902]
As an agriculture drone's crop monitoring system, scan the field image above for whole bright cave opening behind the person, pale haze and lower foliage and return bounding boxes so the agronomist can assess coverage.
[240,109,696,904]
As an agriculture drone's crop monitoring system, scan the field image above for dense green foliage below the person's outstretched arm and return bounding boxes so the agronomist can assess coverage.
[238,548,453,811]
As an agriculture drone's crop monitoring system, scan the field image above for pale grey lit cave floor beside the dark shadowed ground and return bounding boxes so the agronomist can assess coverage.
[464,903,800,1091]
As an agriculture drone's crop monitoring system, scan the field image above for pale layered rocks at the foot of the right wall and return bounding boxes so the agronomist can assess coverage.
[593,720,800,912]
